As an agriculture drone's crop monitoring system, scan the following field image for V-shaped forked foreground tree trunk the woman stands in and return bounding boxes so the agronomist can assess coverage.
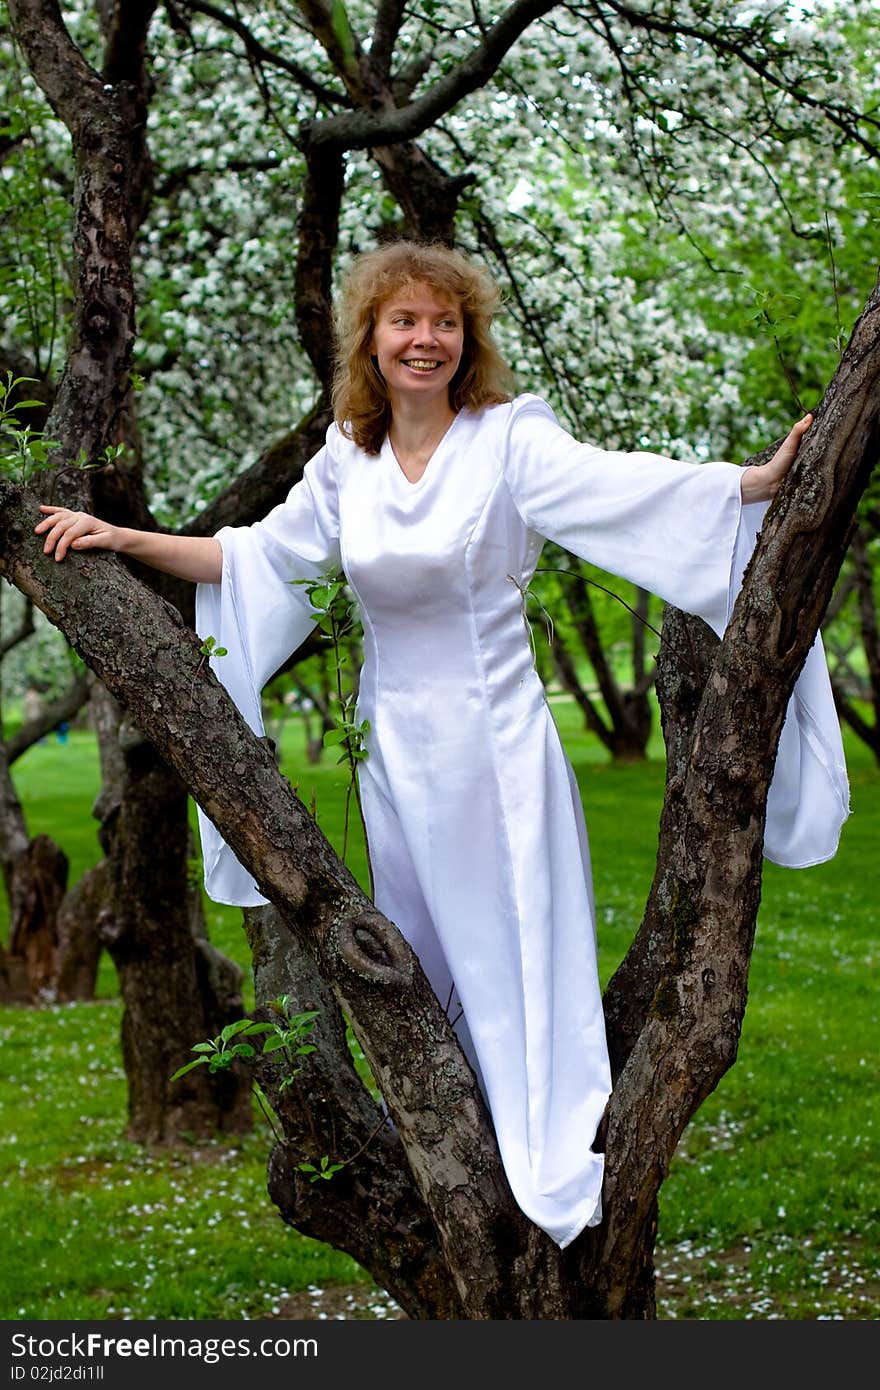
[0,271,880,1319]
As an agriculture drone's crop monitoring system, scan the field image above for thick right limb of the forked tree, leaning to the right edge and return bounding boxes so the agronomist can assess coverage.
[602,273,880,1314]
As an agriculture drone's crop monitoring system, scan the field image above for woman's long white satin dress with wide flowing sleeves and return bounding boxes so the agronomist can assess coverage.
[196,396,848,1245]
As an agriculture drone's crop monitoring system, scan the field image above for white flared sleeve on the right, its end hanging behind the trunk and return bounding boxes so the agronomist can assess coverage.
[505,396,849,867]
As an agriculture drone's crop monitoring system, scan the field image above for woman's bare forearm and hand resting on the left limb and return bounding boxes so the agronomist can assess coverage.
[33,506,222,584]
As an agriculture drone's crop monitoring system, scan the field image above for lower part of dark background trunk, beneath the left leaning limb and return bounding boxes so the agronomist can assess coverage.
[92,688,252,1145]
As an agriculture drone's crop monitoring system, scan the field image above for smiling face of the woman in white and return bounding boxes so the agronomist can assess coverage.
[370,284,464,409]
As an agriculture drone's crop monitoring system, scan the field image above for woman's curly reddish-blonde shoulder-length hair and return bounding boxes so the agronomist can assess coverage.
[332,242,513,453]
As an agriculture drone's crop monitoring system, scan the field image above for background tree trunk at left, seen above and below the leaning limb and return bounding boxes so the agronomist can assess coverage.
[10,0,250,1144]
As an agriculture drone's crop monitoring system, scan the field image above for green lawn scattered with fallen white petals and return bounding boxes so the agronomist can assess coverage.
[0,703,880,1319]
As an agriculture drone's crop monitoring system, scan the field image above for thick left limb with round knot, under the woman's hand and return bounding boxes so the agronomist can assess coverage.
[0,497,559,1319]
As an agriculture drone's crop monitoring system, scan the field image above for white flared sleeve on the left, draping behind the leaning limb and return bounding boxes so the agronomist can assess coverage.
[196,436,339,908]
